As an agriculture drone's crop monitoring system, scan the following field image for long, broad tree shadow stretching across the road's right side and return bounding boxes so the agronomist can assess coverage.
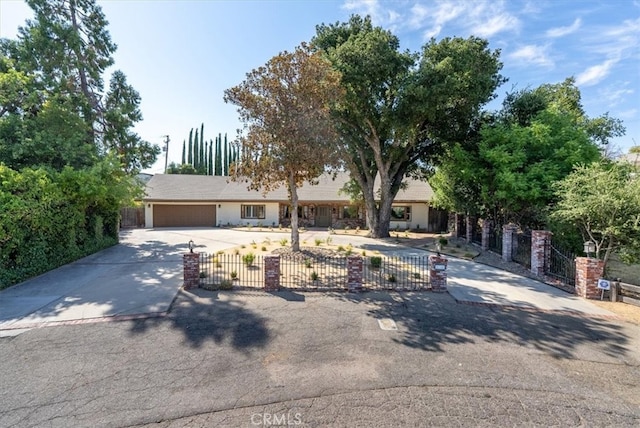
[334,292,638,359]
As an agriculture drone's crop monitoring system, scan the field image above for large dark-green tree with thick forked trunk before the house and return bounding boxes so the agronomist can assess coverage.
[312,16,504,237]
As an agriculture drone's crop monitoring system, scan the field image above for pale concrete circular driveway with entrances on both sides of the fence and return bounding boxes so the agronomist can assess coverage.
[0,229,615,335]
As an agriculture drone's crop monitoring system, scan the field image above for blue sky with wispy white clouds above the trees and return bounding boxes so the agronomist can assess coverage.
[0,0,640,173]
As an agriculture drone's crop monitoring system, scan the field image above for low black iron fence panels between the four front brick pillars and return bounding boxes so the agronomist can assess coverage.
[200,253,429,290]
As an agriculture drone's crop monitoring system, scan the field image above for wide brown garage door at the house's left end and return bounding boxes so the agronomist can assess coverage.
[153,204,216,227]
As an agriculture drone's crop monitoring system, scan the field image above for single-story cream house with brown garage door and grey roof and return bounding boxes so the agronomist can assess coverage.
[143,173,447,232]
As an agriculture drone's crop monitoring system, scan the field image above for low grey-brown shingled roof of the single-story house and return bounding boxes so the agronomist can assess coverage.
[144,173,433,202]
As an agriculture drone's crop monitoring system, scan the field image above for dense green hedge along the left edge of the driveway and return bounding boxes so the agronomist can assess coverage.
[0,161,132,289]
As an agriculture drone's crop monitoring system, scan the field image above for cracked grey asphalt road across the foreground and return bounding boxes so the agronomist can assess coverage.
[0,290,640,427]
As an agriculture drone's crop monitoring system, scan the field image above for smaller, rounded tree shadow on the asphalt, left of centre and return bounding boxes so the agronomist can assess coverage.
[130,289,270,352]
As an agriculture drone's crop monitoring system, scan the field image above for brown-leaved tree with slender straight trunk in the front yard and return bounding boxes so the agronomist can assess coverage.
[224,44,343,251]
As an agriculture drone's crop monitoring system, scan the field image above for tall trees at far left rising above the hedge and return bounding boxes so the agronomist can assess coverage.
[0,0,160,174]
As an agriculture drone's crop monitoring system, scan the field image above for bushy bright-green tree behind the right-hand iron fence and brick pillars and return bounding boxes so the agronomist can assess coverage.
[431,79,606,228]
